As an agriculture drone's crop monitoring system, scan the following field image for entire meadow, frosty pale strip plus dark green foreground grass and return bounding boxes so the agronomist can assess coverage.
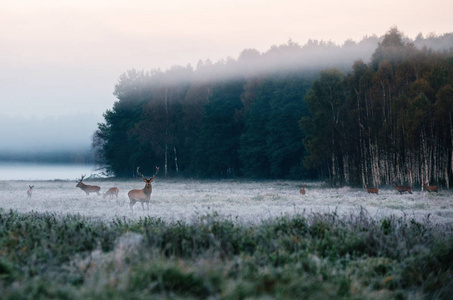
[0,179,453,299]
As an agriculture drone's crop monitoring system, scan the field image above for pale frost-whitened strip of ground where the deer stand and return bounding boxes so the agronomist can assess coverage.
[0,179,453,224]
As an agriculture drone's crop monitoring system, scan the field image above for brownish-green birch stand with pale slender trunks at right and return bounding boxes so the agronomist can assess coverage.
[301,29,453,187]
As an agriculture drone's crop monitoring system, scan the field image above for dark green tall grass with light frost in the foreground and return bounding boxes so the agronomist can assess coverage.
[0,210,453,299]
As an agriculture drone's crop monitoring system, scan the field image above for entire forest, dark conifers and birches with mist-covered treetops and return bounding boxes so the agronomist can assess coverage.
[92,28,453,187]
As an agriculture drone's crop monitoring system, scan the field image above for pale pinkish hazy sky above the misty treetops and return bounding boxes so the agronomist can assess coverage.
[0,0,453,152]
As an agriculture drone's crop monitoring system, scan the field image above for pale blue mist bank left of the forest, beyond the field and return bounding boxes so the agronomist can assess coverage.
[0,111,100,164]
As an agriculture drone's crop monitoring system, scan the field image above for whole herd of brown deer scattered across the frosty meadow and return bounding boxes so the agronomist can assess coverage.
[23,167,439,211]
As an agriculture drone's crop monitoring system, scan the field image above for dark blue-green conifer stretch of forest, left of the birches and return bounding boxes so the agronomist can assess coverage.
[93,68,313,178]
